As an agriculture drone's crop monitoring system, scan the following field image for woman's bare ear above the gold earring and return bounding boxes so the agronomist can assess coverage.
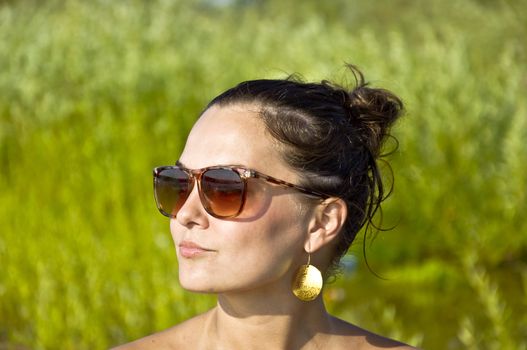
[304,197,348,253]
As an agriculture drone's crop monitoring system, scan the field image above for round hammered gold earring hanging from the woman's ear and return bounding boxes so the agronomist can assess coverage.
[291,253,322,301]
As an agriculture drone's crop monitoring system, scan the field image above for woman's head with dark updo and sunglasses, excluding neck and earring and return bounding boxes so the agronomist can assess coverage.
[155,67,402,294]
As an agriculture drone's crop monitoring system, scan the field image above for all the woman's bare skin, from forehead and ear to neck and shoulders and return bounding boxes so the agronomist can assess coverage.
[116,105,413,350]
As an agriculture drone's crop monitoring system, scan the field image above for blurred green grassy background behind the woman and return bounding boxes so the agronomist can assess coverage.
[0,0,527,350]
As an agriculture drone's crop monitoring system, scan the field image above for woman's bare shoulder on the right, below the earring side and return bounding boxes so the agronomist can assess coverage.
[333,318,417,350]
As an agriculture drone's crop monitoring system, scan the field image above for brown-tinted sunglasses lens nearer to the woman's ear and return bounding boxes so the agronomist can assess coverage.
[201,169,245,218]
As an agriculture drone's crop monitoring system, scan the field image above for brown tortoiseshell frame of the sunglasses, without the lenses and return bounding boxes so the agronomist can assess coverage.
[153,162,330,219]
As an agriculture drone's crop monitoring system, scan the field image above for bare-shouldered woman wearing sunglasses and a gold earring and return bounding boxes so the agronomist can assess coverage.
[119,66,411,349]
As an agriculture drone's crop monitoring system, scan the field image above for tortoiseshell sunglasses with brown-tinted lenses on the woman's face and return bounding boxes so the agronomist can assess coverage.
[154,165,329,219]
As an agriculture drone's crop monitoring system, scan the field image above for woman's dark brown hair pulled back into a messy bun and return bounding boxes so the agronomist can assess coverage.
[207,65,403,270]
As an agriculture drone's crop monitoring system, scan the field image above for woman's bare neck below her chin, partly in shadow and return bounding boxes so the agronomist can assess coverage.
[205,293,331,349]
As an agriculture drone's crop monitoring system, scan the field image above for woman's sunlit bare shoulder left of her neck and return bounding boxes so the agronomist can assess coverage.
[111,311,211,350]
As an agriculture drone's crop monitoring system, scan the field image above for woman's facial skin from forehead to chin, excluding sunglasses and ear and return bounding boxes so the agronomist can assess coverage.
[170,105,310,293]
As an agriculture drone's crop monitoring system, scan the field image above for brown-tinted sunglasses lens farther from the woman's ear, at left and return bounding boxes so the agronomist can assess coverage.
[154,168,192,217]
